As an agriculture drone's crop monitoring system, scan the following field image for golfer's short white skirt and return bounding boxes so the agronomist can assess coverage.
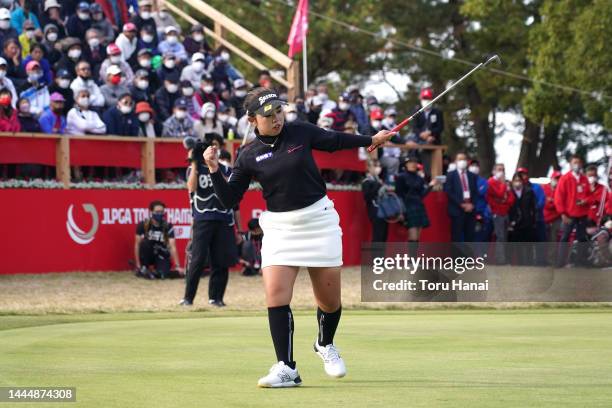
[259,196,342,268]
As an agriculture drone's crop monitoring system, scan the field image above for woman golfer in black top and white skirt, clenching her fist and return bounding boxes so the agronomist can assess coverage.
[204,88,394,388]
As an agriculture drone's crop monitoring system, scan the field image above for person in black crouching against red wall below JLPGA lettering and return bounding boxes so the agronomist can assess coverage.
[134,201,184,279]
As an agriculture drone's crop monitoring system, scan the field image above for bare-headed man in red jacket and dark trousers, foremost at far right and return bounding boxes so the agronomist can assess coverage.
[555,155,589,267]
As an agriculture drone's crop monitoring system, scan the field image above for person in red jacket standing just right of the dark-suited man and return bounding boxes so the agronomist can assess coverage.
[485,163,515,265]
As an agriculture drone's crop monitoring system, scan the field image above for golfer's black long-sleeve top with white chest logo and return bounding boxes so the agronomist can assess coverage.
[211,122,372,212]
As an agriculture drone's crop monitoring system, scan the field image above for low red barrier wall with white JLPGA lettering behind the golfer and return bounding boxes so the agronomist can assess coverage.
[0,189,450,274]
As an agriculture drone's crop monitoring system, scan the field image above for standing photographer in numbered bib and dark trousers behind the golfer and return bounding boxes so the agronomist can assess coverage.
[180,133,238,307]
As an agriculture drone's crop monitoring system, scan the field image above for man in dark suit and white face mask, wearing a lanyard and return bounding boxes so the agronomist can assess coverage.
[444,152,479,242]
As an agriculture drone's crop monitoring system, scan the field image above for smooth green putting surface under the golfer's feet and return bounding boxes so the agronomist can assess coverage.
[0,309,612,408]
